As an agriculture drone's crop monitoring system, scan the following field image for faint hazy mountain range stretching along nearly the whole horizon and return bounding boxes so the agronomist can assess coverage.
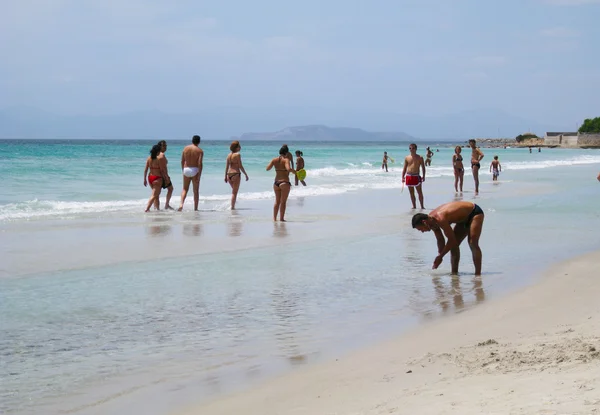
[0,107,572,140]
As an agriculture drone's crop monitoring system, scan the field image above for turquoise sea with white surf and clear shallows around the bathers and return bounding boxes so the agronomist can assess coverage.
[0,140,600,415]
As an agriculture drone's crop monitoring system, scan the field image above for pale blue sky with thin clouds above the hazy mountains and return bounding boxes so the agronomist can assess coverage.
[0,0,600,127]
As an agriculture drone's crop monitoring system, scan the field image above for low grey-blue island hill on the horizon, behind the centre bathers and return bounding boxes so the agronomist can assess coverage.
[237,125,415,143]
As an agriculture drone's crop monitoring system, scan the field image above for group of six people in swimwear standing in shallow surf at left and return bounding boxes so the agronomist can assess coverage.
[144,135,306,222]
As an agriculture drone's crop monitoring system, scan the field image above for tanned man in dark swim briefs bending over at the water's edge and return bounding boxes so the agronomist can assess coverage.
[412,202,485,275]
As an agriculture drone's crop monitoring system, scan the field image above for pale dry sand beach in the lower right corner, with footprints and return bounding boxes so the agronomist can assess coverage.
[176,252,600,415]
